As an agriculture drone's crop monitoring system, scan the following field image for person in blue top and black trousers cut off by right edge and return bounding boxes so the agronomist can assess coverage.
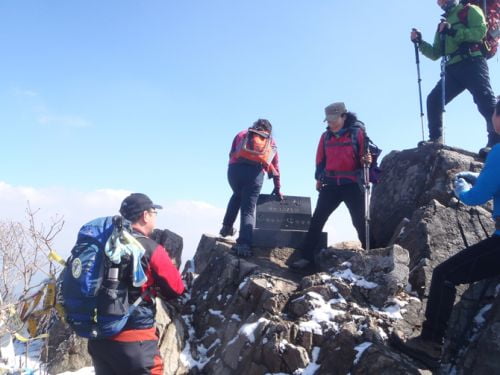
[393,97,500,367]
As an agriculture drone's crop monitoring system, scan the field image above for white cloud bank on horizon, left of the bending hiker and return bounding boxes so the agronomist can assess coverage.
[0,181,224,266]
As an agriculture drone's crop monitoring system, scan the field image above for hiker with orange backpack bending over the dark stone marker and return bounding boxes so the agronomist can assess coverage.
[219,119,283,257]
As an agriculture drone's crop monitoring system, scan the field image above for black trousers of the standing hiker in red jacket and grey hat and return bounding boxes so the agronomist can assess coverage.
[302,182,366,263]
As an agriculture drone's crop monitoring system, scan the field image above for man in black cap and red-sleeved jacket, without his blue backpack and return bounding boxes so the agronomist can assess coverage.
[88,193,185,375]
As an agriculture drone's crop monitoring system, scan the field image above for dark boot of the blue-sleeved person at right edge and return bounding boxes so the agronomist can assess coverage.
[390,333,443,369]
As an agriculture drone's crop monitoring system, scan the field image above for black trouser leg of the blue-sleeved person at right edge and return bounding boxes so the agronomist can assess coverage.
[422,235,500,341]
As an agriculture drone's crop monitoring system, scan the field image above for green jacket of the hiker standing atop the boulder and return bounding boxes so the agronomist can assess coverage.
[420,4,488,65]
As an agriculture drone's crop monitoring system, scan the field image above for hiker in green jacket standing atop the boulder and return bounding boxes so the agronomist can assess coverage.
[410,0,500,157]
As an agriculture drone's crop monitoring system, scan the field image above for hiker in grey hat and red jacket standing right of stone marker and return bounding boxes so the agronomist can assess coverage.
[291,102,379,269]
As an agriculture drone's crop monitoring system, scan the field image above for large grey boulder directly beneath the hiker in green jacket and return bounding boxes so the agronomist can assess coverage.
[371,145,482,247]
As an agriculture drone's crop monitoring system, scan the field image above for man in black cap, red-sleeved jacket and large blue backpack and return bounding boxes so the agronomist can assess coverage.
[61,193,185,375]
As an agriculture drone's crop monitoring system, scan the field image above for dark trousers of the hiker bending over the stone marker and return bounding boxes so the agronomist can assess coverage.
[222,163,264,245]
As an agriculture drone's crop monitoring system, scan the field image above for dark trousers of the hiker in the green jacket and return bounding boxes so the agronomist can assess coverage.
[427,57,500,147]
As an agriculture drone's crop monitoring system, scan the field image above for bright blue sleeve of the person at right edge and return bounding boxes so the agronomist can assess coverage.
[460,146,500,206]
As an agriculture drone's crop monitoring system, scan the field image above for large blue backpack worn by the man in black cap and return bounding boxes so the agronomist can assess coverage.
[61,216,142,339]
